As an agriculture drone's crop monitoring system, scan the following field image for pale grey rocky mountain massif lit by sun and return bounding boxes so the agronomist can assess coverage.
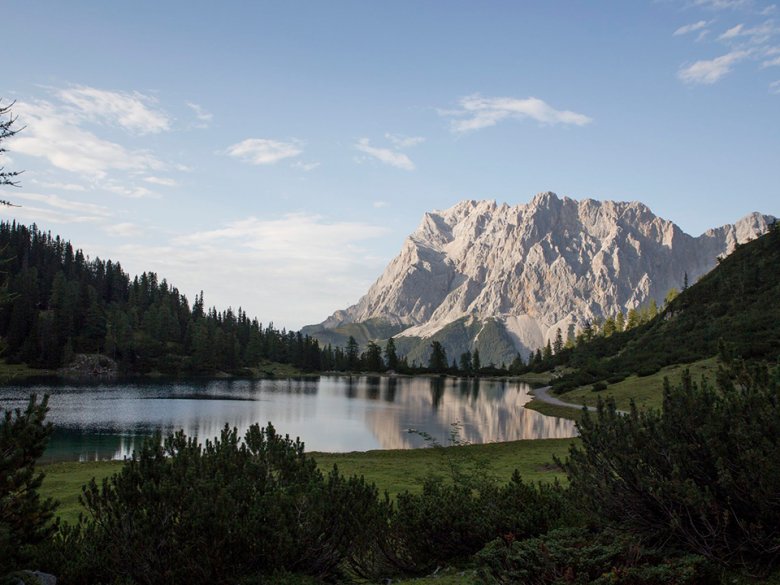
[303,192,774,364]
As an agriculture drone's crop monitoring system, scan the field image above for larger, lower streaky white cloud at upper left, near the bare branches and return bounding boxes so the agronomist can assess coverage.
[11,101,163,179]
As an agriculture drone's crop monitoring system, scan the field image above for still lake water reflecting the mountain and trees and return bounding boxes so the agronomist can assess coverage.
[0,376,576,461]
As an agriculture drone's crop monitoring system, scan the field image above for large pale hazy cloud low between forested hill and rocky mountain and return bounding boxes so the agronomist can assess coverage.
[106,213,389,328]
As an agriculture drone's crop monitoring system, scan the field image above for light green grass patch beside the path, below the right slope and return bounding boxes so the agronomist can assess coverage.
[560,358,718,414]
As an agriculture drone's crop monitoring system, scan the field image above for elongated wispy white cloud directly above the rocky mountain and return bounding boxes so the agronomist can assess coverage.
[440,94,593,132]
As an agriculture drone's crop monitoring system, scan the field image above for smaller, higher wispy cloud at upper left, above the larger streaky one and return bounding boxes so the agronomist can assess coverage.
[57,86,170,134]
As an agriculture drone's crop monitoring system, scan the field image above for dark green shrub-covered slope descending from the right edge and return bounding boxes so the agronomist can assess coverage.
[547,227,780,392]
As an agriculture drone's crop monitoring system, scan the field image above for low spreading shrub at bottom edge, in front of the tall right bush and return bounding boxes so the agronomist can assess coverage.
[476,528,719,585]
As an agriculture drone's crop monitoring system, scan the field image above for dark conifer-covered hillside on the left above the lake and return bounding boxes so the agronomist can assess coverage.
[0,222,323,374]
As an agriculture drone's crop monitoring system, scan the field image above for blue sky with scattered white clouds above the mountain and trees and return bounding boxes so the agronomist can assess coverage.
[0,0,780,329]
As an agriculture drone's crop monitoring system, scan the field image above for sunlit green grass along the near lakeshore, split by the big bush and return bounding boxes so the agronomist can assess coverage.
[40,439,576,522]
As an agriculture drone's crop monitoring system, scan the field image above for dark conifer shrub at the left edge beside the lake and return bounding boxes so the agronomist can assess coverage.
[0,395,56,579]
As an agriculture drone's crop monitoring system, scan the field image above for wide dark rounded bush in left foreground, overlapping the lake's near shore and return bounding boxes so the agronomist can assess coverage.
[41,424,389,584]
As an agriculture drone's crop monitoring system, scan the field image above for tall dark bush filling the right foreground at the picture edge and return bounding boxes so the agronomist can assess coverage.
[564,362,780,566]
